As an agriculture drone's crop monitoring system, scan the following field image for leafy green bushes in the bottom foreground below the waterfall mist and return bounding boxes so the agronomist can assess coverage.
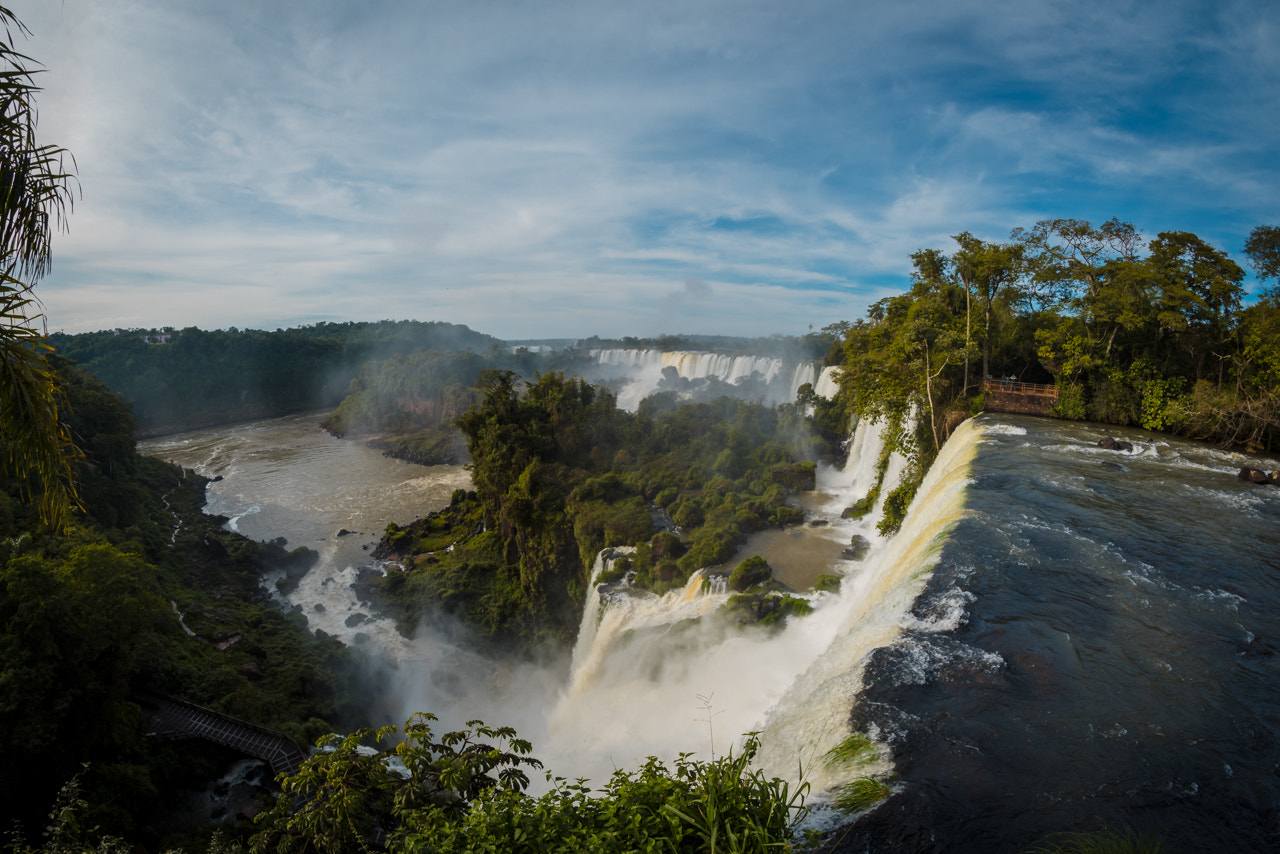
[252,714,808,854]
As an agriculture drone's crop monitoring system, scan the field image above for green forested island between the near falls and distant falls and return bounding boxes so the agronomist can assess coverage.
[371,371,817,644]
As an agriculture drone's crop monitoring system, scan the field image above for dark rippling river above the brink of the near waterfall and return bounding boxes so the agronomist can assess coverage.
[842,417,1280,851]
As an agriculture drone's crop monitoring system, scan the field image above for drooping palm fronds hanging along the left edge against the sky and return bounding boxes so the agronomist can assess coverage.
[0,6,77,526]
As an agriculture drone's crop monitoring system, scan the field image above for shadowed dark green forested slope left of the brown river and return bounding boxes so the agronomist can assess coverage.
[0,360,362,850]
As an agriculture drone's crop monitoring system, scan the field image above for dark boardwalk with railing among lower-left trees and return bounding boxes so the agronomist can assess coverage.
[137,694,307,777]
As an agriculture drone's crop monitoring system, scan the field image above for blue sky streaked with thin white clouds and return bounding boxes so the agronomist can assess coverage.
[8,0,1280,339]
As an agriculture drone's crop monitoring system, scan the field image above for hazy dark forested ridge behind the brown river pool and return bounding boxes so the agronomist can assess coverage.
[49,320,503,434]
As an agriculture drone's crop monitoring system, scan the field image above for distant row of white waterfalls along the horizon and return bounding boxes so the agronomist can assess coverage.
[590,350,837,411]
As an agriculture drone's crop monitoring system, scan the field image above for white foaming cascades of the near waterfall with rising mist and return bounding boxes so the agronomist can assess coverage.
[544,414,972,790]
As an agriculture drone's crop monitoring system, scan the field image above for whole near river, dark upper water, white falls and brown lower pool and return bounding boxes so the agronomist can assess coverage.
[143,407,1280,851]
